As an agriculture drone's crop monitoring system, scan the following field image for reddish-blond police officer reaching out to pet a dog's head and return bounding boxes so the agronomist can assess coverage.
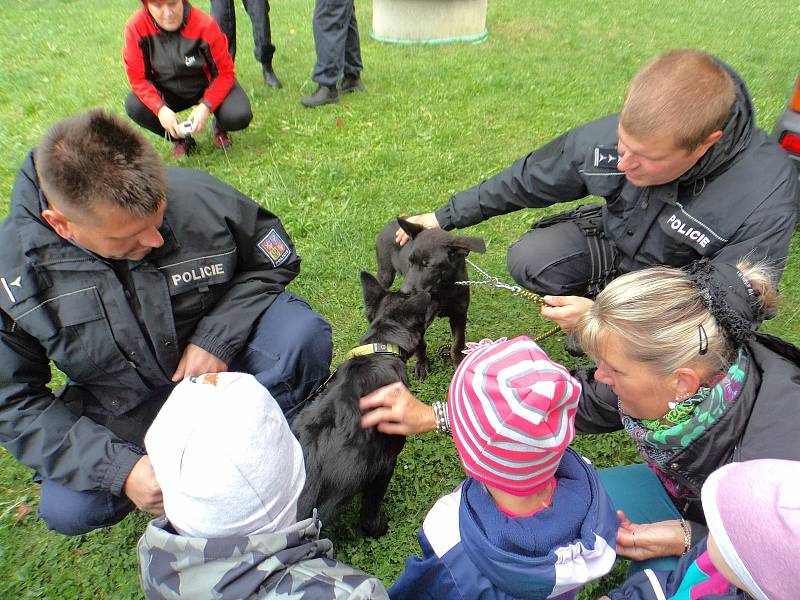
[397,49,798,329]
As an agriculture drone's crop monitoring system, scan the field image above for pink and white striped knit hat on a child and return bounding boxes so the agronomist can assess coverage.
[447,336,581,496]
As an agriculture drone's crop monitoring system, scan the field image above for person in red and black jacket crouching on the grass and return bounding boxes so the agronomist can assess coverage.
[123,0,253,159]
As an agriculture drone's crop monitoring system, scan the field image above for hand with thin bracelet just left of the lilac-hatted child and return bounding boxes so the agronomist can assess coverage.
[617,510,684,560]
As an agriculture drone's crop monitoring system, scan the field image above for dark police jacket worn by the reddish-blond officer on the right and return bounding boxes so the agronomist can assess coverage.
[436,62,800,272]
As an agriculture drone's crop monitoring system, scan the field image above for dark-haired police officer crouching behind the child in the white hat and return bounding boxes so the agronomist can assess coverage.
[0,110,332,535]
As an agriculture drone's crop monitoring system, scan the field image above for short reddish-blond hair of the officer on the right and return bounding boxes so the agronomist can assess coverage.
[619,49,735,152]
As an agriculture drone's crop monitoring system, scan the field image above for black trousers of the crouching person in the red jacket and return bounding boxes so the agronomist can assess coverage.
[125,82,253,137]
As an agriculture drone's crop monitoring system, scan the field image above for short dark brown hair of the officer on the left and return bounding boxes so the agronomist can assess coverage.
[34,109,167,216]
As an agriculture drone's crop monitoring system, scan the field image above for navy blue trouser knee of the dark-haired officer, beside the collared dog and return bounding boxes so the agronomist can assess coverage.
[230,292,333,416]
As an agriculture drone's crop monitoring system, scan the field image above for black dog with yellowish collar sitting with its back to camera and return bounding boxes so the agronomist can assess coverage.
[292,272,432,537]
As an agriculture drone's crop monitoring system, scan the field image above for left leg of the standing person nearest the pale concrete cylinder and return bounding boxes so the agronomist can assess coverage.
[300,0,353,108]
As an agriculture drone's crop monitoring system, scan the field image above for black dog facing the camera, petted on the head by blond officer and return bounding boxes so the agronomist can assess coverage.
[375,218,486,379]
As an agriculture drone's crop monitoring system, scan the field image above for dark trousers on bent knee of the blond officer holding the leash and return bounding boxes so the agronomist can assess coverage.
[506,213,616,297]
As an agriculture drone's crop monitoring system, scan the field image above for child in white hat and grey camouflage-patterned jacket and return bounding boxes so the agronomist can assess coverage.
[138,373,387,600]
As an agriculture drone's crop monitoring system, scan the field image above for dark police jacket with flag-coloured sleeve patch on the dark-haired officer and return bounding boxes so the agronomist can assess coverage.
[0,154,300,494]
